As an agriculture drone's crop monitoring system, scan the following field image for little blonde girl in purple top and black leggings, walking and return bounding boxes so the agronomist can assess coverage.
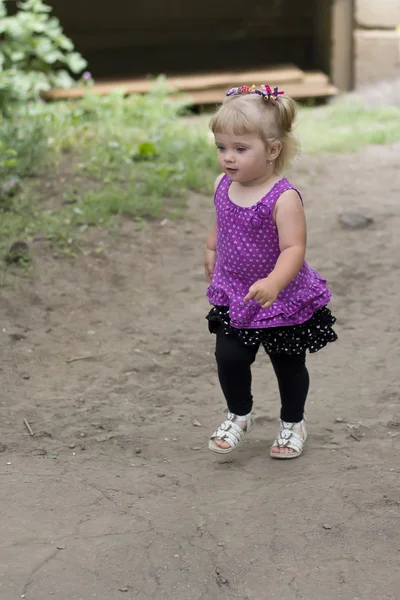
[204,86,337,459]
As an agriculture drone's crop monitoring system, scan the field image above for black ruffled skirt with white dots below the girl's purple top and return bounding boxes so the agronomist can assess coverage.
[206,306,338,354]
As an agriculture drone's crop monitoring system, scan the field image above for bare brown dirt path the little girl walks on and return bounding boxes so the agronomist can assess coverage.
[0,145,400,600]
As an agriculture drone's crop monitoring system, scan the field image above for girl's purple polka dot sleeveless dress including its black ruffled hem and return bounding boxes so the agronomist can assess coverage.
[207,175,337,354]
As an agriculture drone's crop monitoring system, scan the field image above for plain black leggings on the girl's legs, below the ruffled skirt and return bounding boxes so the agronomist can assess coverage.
[215,327,310,423]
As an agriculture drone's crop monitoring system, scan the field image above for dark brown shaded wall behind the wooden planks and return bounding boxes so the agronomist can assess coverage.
[49,0,322,77]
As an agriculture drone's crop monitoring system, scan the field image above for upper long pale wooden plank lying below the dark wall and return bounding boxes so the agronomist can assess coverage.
[42,65,304,100]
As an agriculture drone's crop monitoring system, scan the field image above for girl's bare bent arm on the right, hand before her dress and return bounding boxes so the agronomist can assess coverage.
[244,190,307,308]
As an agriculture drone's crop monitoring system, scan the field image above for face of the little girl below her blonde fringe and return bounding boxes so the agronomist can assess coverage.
[215,133,273,185]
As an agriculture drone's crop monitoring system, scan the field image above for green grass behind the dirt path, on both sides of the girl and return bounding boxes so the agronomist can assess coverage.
[0,86,400,255]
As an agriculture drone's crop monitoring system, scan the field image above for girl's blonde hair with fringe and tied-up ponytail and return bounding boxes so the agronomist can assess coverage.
[210,93,300,173]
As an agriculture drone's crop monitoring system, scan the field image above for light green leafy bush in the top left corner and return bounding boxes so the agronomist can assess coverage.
[0,0,87,114]
